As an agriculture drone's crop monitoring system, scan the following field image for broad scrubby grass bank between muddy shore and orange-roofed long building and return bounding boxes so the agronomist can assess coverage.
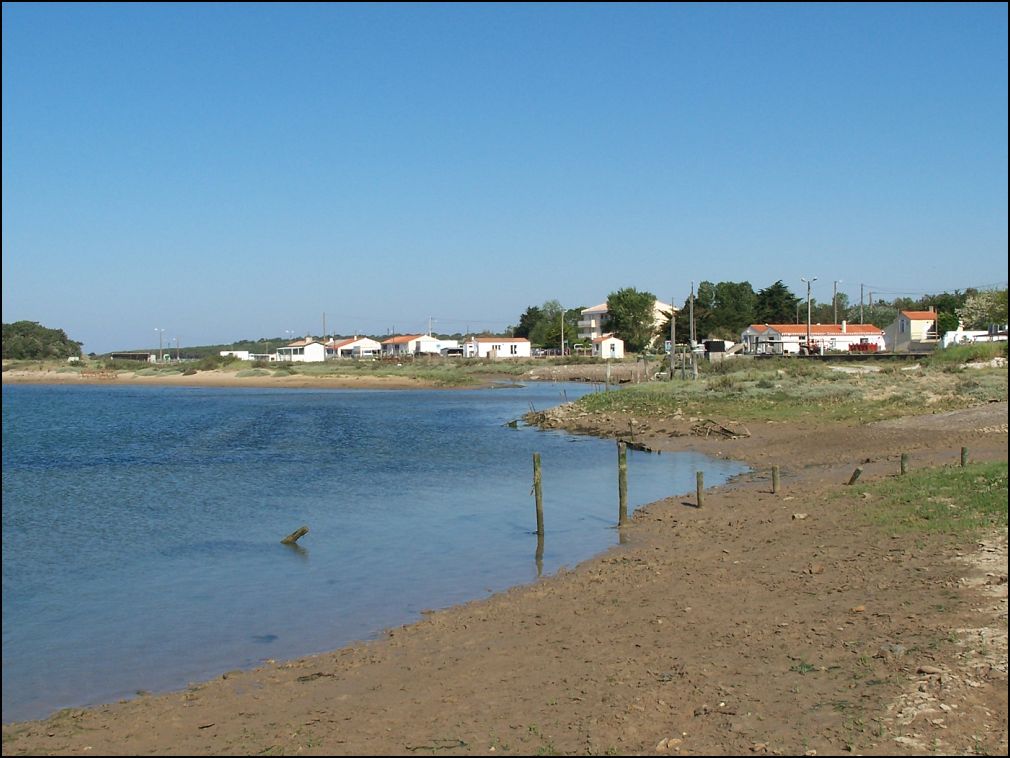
[579,349,1007,423]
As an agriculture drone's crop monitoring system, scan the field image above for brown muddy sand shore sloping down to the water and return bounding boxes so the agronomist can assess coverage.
[3,392,1007,755]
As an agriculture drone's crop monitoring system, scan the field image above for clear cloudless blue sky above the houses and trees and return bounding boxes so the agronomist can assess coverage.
[3,3,1008,353]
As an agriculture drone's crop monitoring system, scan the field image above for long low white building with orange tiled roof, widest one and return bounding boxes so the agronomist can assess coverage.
[740,321,885,355]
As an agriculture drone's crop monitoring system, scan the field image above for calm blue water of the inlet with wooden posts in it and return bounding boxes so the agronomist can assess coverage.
[3,384,743,723]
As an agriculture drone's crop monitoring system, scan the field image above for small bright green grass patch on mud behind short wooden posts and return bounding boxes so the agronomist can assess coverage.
[853,461,1007,538]
